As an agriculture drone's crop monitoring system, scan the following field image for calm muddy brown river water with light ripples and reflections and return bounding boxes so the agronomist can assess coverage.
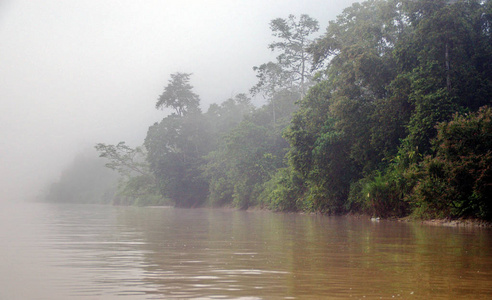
[0,204,492,299]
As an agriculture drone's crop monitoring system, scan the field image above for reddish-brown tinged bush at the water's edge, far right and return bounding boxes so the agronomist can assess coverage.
[409,107,492,219]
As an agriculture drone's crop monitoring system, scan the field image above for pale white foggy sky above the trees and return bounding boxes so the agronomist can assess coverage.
[0,0,355,201]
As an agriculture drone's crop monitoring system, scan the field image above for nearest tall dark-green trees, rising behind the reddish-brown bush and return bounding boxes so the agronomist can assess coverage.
[279,1,492,217]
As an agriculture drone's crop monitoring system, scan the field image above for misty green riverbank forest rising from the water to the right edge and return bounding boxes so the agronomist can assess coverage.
[47,0,492,219]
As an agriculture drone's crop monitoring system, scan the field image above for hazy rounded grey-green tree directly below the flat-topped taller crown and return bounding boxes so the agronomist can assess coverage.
[144,112,213,207]
